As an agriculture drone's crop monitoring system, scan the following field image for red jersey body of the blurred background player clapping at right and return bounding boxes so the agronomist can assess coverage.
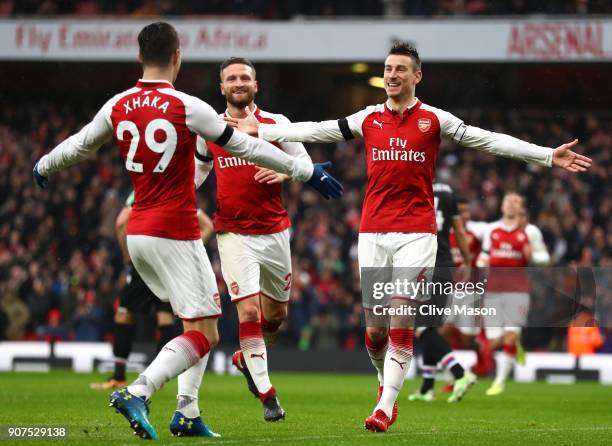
[483,222,529,293]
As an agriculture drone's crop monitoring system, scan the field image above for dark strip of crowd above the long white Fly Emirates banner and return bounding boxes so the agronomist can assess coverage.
[0,0,612,19]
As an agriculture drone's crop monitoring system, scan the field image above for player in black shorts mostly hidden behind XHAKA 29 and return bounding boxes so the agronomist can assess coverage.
[90,192,214,390]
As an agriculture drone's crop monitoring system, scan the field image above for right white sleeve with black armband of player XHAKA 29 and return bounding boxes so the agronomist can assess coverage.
[185,95,313,181]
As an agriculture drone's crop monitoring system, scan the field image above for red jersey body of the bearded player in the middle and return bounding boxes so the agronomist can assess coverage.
[207,108,306,235]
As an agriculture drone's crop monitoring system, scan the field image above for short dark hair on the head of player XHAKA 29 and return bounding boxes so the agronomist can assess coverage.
[138,22,180,67]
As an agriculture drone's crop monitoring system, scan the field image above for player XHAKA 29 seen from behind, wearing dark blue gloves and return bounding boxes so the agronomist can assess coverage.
[33,22,342,439]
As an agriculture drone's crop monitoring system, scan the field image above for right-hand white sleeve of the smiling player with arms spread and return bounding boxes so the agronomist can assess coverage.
[431,107,553,167]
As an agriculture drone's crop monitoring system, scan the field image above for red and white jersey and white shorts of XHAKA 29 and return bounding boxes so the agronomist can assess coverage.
[38,80,313,319]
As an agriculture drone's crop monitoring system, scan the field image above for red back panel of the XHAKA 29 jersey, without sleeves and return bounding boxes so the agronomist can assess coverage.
[111,81,200,240]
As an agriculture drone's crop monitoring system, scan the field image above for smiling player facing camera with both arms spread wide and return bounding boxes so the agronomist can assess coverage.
[225,43,591,432]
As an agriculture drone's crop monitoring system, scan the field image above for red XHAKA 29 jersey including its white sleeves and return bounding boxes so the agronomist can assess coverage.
[37,79,313,240]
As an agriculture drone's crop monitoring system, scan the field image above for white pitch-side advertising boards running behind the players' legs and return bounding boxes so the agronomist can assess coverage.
[0,342,612,384]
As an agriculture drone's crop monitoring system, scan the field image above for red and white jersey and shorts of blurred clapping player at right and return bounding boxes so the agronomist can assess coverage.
[482,220,549,339]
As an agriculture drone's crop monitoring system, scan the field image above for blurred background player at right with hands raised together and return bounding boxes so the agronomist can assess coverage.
[478,191,550,396]
